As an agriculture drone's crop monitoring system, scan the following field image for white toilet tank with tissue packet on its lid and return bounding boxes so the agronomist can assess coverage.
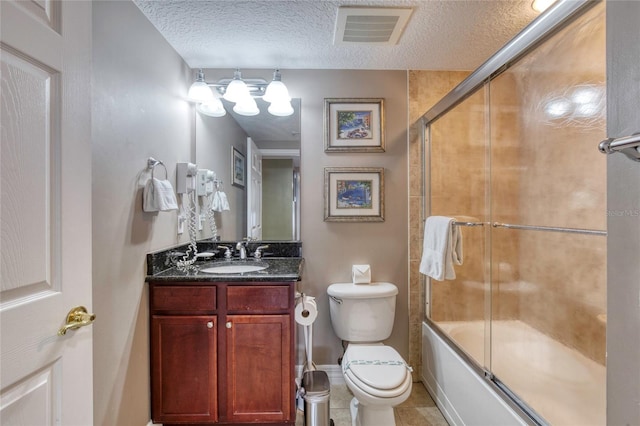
[327,282,398,343]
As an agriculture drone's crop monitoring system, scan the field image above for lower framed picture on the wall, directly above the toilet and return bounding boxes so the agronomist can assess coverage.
[324,167,384,222]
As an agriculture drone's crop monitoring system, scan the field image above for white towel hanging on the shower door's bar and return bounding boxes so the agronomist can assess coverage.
[420,216,462,281]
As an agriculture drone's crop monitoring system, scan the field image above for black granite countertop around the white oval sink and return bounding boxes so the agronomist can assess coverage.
[146,257,304,282]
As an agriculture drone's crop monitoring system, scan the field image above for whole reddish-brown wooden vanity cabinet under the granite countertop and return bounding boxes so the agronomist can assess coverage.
[150,282,295,426]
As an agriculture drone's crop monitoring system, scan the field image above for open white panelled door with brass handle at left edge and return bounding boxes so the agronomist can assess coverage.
[0,0,93,426]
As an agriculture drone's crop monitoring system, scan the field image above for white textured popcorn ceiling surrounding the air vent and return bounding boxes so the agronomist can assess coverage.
[134,0,537,70]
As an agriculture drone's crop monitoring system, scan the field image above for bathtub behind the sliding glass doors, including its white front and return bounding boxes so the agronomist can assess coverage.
[422,321,606,426]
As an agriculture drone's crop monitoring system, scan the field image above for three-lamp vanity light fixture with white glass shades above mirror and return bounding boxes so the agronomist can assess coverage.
[188,69,294,117]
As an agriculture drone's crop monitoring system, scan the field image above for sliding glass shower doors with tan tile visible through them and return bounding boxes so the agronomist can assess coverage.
[425,2,607,425]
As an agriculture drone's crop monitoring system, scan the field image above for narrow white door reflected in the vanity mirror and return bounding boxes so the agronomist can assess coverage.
[247,138,262,240]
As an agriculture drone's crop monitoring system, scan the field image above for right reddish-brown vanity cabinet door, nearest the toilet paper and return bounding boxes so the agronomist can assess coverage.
[226,315,295,422]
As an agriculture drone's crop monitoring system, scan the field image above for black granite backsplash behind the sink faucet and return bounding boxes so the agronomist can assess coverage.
[147,240,302,276]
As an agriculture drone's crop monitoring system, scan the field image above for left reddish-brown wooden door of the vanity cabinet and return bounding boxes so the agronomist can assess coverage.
[151,315,218,423]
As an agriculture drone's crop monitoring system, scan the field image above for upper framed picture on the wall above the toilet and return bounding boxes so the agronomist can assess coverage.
[324,98,384,152]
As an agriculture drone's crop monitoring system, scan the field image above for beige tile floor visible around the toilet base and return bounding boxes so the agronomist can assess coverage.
[296,383,448,426]
